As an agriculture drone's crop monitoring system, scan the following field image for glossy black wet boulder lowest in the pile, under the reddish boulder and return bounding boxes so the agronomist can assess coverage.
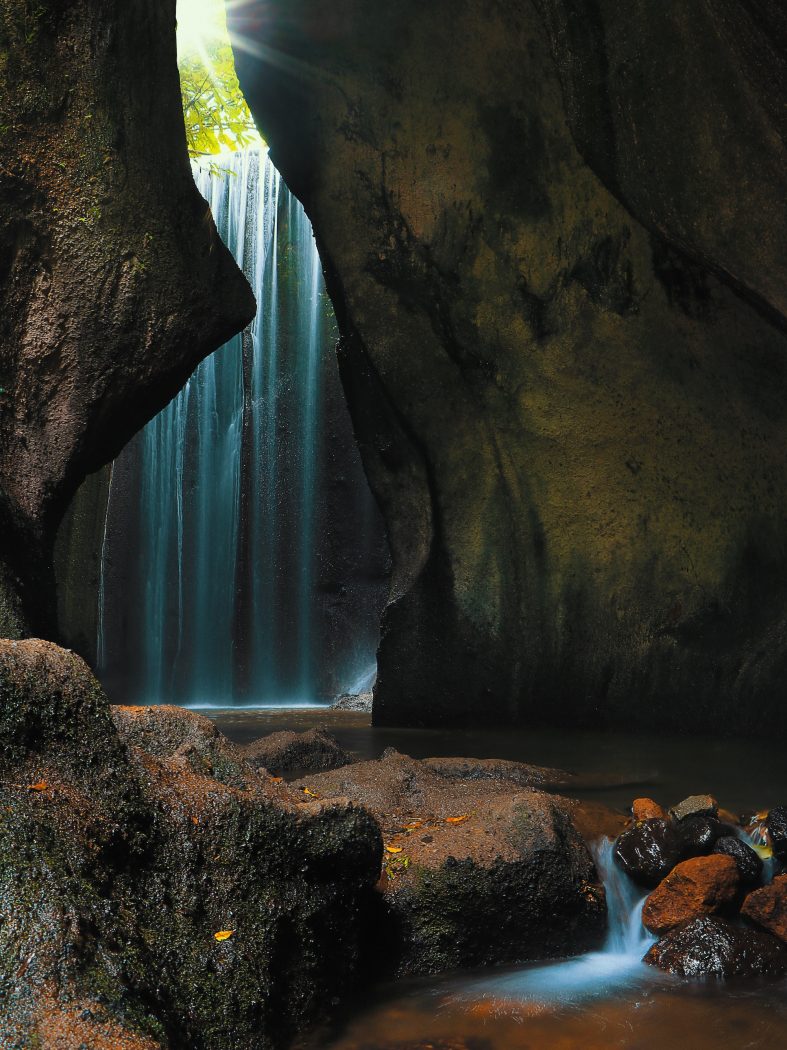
[644,916,787,978]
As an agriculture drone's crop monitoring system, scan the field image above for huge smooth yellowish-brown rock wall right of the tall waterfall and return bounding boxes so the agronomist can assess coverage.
[230,0,787,732]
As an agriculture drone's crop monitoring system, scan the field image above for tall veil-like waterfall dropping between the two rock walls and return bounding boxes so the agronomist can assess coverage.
[98,149,385,706]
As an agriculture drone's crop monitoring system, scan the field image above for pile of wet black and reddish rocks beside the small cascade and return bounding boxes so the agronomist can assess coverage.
[615,795,787,978]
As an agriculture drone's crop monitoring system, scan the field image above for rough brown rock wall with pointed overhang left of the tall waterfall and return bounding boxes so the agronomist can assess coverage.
[0,0,254,633]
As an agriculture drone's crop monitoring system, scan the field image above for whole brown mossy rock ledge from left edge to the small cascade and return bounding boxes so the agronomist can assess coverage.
[0,641,615,1050]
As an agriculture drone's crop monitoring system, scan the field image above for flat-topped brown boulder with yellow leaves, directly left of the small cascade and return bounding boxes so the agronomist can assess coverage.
[291,750,605,974]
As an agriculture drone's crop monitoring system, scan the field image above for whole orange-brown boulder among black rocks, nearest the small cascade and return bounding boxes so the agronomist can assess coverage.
[642,856,741,933]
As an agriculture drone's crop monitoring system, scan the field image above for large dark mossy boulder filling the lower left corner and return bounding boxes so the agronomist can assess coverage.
[0,641,382,1050]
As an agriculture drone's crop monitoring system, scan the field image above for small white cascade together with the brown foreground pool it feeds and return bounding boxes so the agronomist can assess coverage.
[310,840,787,1050]
